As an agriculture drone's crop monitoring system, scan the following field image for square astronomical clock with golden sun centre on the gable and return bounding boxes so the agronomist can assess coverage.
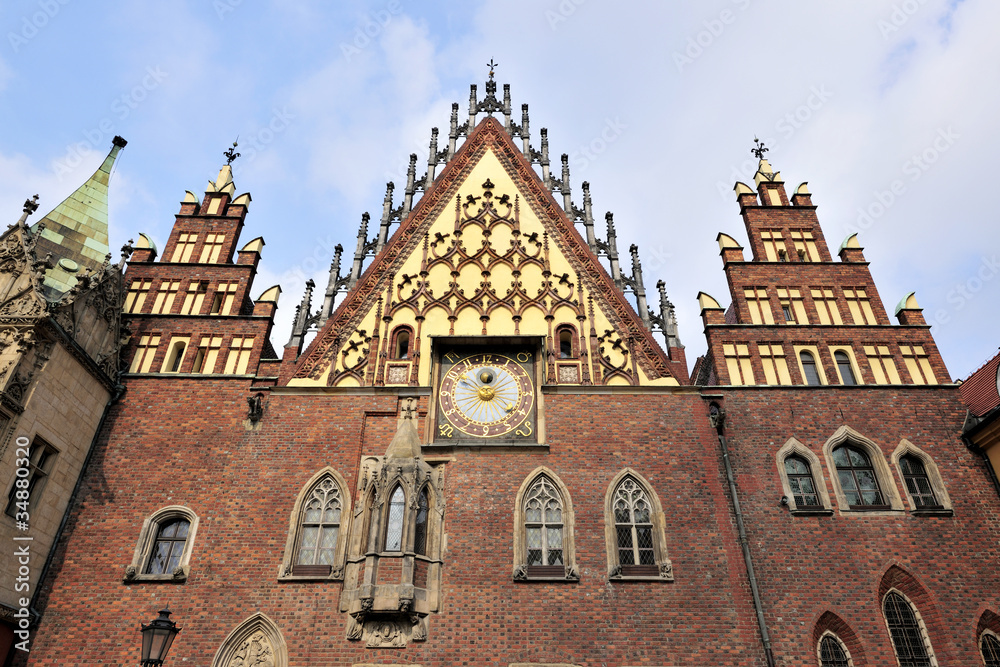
[436,351,535,441]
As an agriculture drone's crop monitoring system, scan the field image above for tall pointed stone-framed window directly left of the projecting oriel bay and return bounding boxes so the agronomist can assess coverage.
[278,467,351,580]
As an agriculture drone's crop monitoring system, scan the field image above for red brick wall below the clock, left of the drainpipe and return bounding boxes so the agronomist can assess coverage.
[32,388,763,667]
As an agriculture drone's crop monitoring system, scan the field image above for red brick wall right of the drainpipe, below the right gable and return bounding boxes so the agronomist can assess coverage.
[722,387,1000,666]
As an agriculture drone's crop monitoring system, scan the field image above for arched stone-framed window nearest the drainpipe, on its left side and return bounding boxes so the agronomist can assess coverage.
[604,468,674,581]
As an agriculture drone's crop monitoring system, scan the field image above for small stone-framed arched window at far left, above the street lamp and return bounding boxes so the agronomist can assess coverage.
[124,505,198,583]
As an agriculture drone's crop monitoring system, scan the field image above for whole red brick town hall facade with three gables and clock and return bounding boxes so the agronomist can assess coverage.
[15,75,1000,667]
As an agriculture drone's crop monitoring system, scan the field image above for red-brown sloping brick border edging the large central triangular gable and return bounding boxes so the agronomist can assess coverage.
[293,116,676,384]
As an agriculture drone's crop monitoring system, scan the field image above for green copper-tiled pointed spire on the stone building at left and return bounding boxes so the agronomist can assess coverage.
[31,137,127,299]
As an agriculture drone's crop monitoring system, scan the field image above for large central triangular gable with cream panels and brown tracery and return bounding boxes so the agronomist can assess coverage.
[290,117,677,386]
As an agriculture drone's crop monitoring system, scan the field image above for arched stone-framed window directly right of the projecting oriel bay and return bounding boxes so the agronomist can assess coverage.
[514,466,580,581]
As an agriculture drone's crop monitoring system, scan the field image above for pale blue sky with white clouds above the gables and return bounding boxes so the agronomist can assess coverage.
[0,0,1000,378]
